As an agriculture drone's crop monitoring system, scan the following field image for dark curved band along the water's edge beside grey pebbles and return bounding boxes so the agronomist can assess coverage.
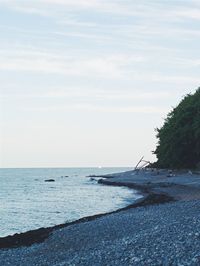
[0,179,176,249]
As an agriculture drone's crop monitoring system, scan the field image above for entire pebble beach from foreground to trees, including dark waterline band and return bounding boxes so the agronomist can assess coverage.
[0,171,200,266]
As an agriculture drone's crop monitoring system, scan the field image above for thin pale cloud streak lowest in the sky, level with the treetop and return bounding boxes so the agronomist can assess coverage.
[0,89,171,102]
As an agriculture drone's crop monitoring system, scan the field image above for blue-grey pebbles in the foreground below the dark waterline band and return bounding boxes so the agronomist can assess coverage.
[0,200,200,266]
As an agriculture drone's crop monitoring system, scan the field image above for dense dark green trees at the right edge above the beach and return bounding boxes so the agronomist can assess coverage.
[154,88,200,169]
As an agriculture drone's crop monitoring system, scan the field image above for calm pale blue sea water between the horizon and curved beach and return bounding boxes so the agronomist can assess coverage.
[0,168,140,237]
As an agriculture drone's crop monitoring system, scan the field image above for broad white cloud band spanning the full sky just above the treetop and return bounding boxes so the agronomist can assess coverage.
[0,47,200,85]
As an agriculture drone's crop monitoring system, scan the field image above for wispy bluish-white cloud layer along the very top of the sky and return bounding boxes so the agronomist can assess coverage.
[0,0,200,45]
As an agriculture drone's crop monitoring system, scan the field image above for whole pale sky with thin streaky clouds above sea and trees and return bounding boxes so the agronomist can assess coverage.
[0,0,200,167]
